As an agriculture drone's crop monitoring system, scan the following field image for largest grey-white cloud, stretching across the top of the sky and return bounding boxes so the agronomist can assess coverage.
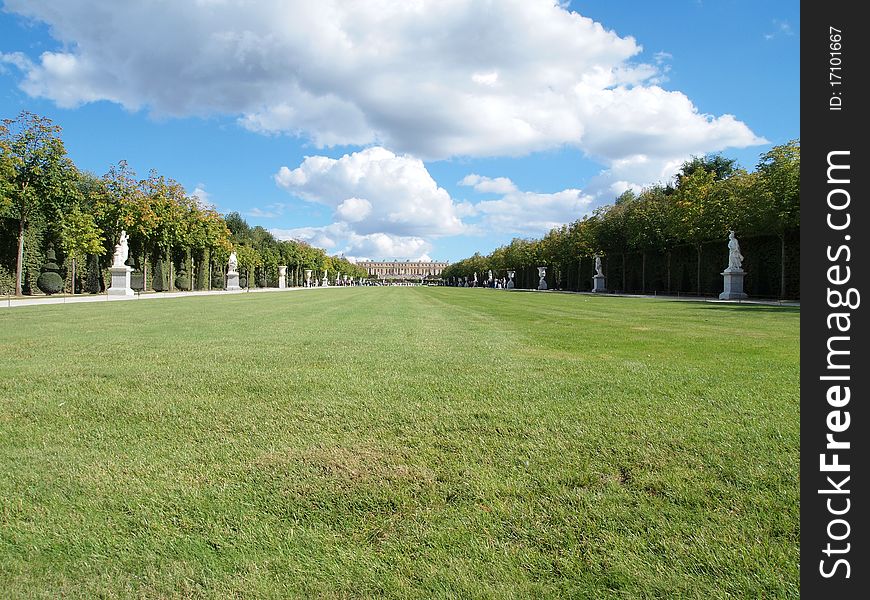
[2,0,764,165]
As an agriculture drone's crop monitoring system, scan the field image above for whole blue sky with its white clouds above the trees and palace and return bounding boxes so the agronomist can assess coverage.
[0,0,800,261]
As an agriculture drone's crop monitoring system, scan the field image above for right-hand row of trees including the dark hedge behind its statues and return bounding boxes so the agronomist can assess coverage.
[442,140,800,298]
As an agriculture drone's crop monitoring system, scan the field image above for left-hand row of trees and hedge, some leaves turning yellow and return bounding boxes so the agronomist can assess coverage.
[0,112,366,295]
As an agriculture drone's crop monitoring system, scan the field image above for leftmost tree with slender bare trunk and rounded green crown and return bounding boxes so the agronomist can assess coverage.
[0,111,75,295]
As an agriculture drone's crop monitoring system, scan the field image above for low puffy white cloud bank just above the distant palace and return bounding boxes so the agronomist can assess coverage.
[271,147,593,259]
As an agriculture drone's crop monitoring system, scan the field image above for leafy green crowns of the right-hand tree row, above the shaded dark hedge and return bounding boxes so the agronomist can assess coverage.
[442,140,800,297]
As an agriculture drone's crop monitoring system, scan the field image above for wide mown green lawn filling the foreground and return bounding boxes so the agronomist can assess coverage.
[0,288,800,598]
